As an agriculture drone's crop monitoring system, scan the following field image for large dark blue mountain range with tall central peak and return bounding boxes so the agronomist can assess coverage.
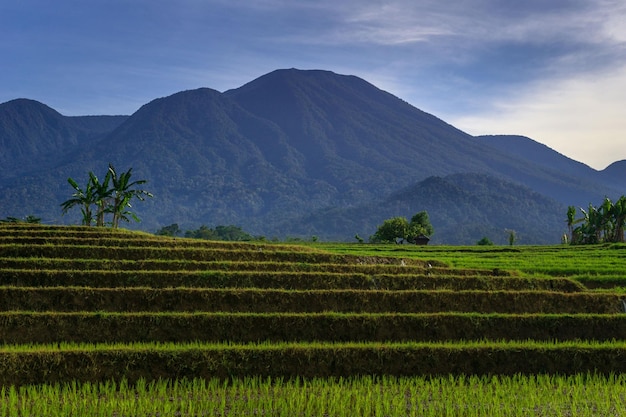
[0,69,619,243]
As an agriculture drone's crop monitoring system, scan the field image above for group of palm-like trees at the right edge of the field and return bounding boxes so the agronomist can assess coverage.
[567,196,626,244]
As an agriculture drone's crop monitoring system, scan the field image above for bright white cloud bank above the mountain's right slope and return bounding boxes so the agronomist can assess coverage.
[449,66,626,169]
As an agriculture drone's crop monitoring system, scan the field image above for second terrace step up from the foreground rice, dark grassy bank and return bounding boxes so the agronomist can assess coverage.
[0,312,626,344]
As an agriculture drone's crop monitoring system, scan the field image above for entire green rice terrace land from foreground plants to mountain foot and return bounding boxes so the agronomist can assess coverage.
[0,223,626,416]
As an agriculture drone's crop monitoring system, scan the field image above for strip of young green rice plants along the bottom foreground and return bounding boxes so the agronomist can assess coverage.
[0,374,626,417]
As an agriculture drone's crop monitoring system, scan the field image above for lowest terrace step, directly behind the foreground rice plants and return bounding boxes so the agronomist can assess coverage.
[0,342,626,386]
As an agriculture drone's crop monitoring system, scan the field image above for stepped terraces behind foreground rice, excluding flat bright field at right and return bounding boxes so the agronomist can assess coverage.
[0,224,626,386]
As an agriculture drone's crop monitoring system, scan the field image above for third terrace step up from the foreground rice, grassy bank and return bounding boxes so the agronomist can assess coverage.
[0,287,623,314]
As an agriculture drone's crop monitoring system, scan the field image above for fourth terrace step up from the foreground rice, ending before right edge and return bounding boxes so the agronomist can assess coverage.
[0,265,585,292]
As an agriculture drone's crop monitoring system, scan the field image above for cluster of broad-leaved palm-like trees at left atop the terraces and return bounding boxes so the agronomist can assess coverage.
[61,164,152,228]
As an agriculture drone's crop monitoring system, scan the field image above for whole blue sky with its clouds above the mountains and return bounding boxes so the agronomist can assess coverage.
[0,0,626,169]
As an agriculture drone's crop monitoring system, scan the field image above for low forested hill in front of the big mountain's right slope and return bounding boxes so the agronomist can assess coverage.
[284,174,567,245]
